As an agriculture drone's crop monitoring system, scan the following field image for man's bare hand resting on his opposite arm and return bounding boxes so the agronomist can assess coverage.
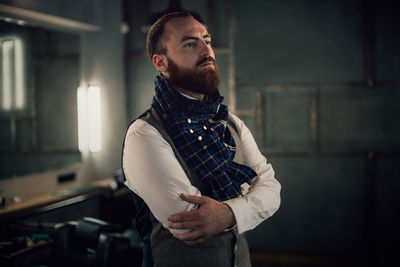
[168,194,235,245]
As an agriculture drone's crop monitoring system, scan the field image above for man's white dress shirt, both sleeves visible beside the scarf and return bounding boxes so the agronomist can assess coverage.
[123,113,281,233]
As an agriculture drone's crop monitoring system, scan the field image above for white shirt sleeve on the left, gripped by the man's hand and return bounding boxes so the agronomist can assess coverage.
[123,119,201,232]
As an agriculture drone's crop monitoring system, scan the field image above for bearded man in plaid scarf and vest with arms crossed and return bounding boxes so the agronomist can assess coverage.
[122,12,281,267]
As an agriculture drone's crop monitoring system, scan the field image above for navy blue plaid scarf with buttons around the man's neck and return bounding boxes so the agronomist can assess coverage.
[152,75,257,201]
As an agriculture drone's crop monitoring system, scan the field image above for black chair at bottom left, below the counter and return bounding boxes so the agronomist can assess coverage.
[50,217,142,267]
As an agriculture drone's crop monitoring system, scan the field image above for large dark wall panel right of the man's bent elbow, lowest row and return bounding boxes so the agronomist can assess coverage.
[247,154,366,253]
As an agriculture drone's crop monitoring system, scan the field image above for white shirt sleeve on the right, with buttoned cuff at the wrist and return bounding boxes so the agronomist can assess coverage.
[224,114,281,233]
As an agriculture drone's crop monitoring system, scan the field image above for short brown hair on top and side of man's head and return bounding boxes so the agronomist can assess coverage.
[146,11,197,60]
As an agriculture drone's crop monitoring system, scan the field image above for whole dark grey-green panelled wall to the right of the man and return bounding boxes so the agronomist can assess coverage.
[233,0,400,261]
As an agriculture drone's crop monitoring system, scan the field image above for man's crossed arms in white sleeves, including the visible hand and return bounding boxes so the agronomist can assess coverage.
[123,114,280,245]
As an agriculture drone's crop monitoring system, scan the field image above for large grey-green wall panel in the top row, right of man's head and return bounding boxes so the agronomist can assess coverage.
[233,0,364,86]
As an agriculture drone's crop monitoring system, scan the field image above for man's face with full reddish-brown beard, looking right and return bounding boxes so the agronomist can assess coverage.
[160,17,220,94]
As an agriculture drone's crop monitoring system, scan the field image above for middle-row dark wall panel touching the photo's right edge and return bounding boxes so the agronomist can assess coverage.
[320,88,400,150]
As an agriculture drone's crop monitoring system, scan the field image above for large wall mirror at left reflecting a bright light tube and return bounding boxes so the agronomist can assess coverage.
[0,18,81,178]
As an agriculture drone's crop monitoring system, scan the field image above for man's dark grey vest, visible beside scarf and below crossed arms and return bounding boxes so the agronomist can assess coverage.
[141,109,251,267]
